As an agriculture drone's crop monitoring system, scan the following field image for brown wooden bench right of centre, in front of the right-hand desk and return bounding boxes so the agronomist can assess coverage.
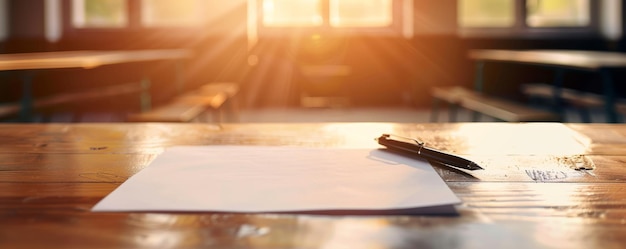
[431,86,560,122]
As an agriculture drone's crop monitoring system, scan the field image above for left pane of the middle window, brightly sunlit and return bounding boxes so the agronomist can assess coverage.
[263,0,324,27]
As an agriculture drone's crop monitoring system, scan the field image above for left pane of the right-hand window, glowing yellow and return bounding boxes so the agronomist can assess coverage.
[458,0,515,28]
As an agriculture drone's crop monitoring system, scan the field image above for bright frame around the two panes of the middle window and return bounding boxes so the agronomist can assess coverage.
[255,0,405,37]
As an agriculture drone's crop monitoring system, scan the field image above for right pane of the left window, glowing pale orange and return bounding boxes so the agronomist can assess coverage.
[141,0,207,27]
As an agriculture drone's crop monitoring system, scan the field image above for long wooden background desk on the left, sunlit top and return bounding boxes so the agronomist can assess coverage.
[0,49,191,121]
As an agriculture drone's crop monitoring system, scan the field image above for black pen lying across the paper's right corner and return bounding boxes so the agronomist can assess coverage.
[377,134,483,170]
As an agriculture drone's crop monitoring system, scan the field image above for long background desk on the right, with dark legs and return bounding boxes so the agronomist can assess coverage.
[469,50,626,123]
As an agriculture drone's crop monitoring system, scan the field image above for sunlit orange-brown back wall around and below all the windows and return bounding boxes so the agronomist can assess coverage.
[0,0,624,111]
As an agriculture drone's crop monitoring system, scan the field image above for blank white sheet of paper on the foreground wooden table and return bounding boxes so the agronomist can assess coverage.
[93,146,460,212]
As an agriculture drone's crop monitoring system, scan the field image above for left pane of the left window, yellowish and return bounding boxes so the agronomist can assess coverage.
[72,0,128,28]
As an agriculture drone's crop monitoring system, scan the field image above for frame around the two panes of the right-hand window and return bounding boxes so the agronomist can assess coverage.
[456,0,601,39]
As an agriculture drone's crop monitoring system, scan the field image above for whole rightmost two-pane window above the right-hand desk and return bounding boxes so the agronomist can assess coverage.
[457,0,600,37]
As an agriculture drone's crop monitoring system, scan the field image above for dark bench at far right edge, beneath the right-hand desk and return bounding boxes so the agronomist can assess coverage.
[521,83,626,123]
